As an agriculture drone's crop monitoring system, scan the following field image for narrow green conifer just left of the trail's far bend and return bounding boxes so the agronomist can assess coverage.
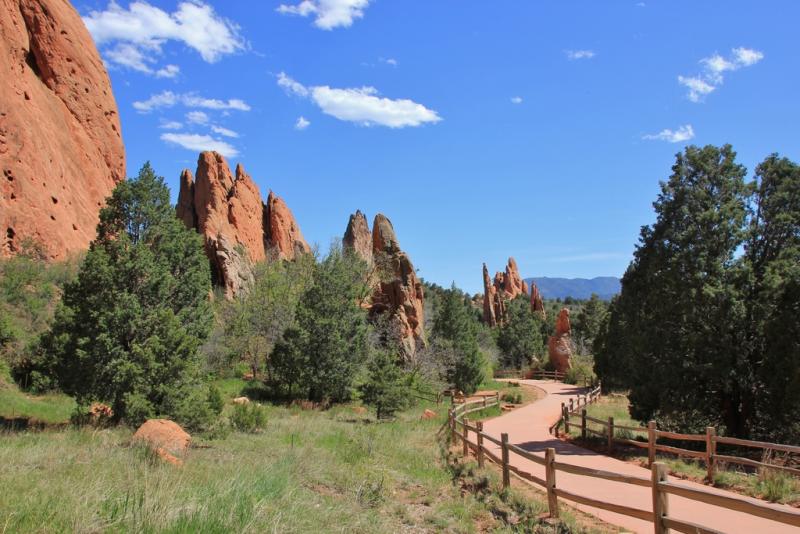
[433,284,487,394]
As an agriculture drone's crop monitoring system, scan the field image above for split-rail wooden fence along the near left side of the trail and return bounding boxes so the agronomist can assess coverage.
[448,392,800,534]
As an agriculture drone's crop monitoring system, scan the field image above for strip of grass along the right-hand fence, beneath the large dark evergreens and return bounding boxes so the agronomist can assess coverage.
[570,395,800,506]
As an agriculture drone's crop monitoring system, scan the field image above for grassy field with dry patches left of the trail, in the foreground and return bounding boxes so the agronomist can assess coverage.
[0,380,608,533]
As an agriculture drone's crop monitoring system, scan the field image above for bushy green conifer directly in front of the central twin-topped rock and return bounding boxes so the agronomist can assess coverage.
[267,246,368,402]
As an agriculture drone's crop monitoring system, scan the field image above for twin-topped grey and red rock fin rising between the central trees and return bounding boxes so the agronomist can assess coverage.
[342,211,425,359]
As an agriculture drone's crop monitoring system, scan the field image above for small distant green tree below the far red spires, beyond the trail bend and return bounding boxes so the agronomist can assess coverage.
[497,295,544,369]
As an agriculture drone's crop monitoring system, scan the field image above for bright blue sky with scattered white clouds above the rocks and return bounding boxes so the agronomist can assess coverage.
[75,0,800,292]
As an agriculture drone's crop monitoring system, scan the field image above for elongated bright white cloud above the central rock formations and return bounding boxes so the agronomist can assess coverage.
[278,72,442,128]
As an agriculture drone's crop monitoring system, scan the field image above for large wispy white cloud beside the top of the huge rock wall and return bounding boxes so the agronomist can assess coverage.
[83,0,245,77]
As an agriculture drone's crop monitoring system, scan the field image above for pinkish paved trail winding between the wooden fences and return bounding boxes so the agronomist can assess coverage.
[483,380,800,534]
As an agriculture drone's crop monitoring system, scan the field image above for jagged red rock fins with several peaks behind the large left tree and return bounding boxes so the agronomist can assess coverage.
[176,152,311,297]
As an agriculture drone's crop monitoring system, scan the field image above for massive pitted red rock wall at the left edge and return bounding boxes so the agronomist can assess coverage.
[0,0,125,259]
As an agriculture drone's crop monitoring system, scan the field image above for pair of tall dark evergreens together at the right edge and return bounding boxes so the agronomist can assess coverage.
[595,146,800,439]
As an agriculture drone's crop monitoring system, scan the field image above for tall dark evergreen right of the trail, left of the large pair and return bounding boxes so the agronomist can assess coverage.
[598,146,750,432]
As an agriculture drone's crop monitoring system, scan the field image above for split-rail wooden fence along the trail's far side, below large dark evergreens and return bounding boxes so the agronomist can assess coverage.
[551,396,800,482]
